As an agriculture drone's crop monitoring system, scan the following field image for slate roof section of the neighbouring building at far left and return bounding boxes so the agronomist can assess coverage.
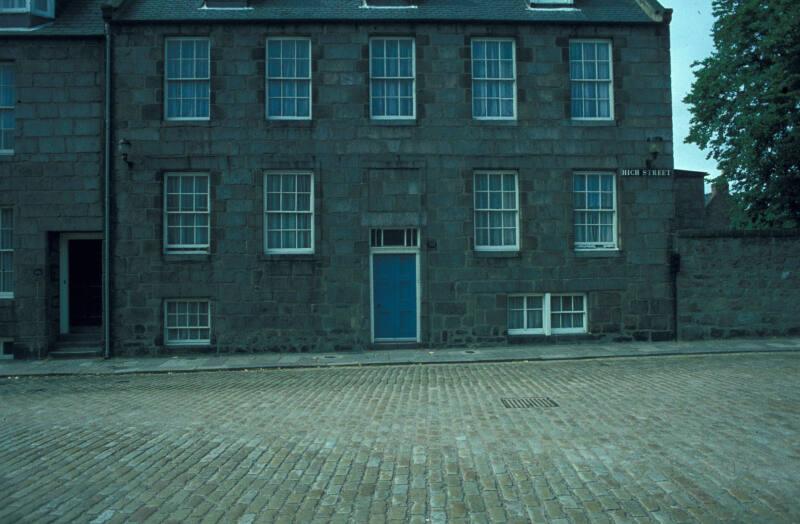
[0,0,104,37]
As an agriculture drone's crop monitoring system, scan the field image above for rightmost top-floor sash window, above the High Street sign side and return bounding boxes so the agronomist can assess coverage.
[569,40,614,120]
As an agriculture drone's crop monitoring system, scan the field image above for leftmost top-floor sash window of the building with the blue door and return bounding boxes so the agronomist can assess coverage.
[164,38,211,120]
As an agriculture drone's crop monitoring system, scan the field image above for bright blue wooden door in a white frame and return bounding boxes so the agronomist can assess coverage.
[372,253,417,340]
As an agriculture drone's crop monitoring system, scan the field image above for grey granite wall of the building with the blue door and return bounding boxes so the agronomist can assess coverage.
[112,24,675,354]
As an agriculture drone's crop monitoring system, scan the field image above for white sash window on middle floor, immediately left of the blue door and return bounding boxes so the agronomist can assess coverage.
[264,172,314,253]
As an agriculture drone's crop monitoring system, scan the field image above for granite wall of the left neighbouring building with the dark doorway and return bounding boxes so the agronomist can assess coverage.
[0,37,103,356]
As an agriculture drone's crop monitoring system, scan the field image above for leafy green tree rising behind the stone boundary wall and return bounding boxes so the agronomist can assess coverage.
[684,0,800,227]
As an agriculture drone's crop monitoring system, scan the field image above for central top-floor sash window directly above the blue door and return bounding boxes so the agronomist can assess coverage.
[369,38,416,120]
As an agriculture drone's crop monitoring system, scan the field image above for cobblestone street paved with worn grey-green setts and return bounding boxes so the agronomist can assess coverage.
[0,354,800,523]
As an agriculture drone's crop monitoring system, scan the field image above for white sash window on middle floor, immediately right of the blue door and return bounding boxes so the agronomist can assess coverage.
[474,172,519,251]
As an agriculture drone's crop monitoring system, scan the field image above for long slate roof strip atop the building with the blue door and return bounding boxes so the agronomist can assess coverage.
[115,0,654,23]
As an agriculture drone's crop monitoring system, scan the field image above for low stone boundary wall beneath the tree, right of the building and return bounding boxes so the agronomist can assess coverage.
[676,231,800,340]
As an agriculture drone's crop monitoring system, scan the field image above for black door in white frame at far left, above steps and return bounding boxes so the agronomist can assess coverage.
[69,239,103,326]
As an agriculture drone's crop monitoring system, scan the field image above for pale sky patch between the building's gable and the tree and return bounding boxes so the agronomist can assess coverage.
[660,0,719,177]
